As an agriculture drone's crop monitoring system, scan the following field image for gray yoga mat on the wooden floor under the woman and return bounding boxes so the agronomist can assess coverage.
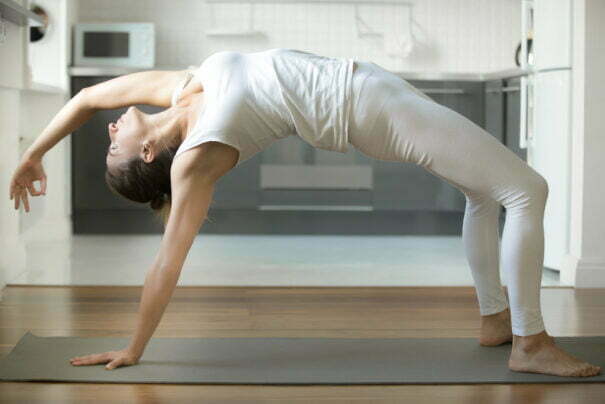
[0,332,605,385]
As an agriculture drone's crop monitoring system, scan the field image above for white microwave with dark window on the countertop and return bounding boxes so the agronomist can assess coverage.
[73,22,155,68]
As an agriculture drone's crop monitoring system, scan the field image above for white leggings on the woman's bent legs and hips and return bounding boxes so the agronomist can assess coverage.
[349,61,548,336]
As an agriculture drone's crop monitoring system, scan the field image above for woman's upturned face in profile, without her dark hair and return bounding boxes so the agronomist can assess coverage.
[106,106,147,167]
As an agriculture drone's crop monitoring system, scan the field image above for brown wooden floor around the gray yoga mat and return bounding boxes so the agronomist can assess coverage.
[0,286,605,404]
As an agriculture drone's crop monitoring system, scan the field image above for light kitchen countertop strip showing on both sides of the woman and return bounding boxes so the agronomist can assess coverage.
[68,66,529,81]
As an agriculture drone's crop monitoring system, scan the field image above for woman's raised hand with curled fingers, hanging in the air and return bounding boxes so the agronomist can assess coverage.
[9,156,46,212]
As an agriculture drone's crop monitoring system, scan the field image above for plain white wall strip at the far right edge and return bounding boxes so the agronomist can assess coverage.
[562,0,605,288]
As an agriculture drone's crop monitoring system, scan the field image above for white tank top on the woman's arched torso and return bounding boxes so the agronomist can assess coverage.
[172,48,354,165]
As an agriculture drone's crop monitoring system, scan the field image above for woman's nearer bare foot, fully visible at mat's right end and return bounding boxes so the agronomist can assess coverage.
[508,331,601,377]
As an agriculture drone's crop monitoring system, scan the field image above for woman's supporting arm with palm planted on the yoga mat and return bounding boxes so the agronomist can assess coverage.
[72,142,238,369]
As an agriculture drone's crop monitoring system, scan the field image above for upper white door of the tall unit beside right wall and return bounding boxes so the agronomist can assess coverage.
[532,0,571,70]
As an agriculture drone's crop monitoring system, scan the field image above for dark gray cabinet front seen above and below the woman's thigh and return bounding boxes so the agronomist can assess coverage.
[372,80,484,211]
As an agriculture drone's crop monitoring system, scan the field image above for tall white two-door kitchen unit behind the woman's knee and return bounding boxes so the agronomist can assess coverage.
[519,0,572,271]
